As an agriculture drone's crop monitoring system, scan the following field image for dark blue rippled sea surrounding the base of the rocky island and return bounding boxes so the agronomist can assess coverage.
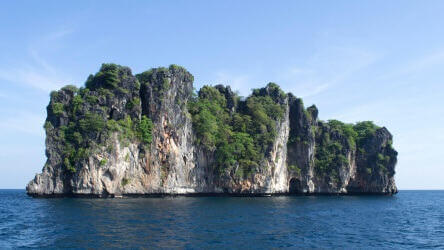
[0,190,444,249]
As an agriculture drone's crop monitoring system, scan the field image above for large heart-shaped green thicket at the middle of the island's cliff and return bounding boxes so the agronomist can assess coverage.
[189,83,285,177]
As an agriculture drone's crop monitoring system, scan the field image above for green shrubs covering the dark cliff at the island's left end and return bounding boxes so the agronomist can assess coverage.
[44,64,153,173]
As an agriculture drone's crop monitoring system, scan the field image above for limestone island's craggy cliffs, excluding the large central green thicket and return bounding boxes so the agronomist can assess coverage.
[26,64,397,197]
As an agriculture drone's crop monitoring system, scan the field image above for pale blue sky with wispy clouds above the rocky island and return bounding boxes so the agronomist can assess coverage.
[0,0,444,189]
